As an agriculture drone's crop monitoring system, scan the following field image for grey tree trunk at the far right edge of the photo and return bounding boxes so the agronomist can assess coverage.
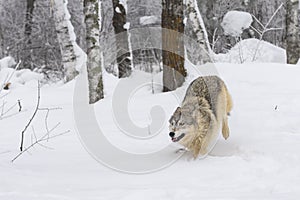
[286,0,300,64]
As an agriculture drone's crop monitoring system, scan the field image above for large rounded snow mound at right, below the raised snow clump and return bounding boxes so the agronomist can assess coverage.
[215,38,286,63]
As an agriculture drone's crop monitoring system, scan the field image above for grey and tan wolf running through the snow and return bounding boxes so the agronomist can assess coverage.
[169,76,233,158]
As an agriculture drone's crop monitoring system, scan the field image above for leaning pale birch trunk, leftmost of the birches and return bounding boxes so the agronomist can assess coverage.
[53,0,78,82]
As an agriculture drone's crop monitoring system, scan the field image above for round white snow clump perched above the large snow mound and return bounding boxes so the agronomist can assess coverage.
[221,10,253,37]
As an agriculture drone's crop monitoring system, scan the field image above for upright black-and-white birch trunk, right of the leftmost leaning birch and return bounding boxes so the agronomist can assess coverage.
[84,0,104,104]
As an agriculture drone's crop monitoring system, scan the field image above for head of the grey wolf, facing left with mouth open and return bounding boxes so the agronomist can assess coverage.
[169,107,195,142]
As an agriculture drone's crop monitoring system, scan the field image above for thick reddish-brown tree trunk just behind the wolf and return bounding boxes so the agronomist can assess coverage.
[162,0,186,92]
